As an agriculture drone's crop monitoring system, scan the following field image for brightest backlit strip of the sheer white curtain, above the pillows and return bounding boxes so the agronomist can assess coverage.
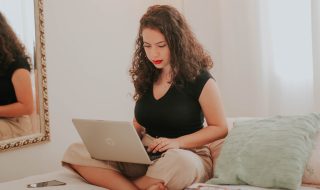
[259,0,314,114]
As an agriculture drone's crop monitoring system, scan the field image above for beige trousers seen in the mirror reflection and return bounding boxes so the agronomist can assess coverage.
[0,115,33,140]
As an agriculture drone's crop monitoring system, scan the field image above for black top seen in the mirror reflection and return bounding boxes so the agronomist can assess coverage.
[0,58,31,105]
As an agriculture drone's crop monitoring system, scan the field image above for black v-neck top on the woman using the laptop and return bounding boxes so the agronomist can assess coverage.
[135,71,213,138]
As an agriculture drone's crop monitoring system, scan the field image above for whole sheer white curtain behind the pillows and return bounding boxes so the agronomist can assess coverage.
[213,0,320,116]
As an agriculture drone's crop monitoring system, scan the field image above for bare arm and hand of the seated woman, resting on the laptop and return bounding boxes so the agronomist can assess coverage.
[149,79,228,152]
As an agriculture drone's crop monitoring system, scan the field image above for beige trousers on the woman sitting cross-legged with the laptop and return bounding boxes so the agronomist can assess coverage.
[62,135,212,190]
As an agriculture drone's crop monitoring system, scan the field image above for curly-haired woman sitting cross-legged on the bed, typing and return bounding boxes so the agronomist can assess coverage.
[63,5,227,190]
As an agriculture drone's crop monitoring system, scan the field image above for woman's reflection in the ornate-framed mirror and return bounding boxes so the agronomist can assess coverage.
[0,12,34,140]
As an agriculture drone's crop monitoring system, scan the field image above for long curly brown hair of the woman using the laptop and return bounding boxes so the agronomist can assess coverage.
[129,5,213,100]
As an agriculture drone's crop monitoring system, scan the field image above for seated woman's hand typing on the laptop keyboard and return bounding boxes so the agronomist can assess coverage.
[148,137,180,153]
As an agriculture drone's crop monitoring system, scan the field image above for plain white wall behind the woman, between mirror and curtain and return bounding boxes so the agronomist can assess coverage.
[0,0,214,181]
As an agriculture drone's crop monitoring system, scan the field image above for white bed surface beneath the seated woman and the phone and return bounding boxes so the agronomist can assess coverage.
[0,168,320,190]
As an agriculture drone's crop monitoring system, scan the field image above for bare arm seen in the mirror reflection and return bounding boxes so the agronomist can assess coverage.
[0,69,33,117]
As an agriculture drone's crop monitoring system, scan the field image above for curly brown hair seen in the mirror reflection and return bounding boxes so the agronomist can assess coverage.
[0,12,31,74]
